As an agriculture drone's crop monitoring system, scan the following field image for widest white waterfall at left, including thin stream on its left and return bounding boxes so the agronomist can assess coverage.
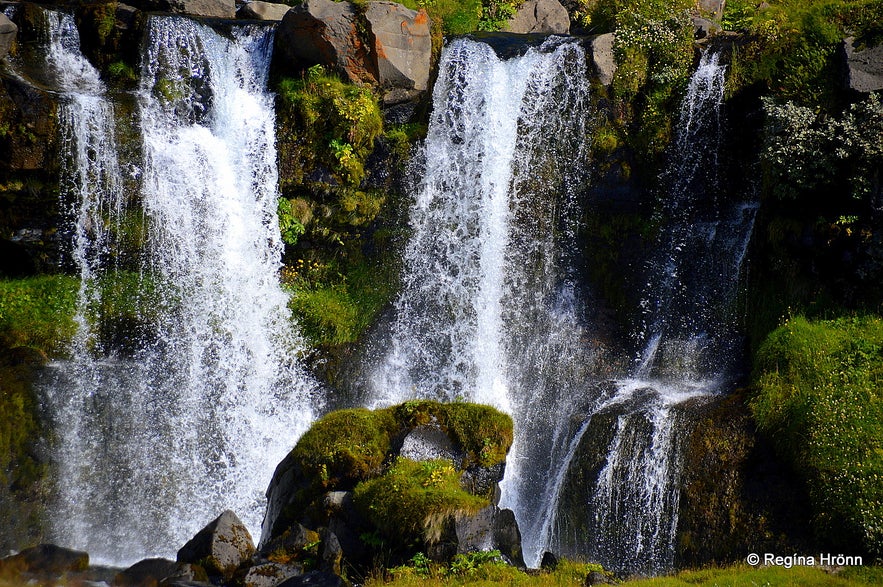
[46,16,315,563]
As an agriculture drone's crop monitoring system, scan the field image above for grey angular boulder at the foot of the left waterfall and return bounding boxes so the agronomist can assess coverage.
[178,510,255,579]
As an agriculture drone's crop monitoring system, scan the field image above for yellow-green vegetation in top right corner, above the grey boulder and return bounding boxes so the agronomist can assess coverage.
[723,0,883,107]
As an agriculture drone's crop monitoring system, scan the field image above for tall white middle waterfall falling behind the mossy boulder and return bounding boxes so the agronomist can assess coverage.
[368,38,596,563]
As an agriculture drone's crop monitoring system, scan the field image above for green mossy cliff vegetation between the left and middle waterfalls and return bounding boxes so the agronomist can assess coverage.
[277,66,404,347]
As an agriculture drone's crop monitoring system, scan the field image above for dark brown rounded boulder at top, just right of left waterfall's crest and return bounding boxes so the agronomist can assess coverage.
[276,0,378,83]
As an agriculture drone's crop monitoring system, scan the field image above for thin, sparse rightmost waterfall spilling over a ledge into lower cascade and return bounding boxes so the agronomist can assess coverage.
[548,53,756,574]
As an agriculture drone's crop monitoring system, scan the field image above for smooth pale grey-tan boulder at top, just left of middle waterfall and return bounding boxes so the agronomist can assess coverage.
[365,2,432,91]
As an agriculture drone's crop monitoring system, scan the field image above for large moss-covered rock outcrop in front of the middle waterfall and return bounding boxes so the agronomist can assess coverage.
[261,400,521,564]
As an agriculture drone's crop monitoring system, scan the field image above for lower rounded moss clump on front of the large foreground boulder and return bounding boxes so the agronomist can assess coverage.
[355,458,489,546]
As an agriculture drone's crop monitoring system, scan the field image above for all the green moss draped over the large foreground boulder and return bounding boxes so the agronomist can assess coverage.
[277,400,512,548]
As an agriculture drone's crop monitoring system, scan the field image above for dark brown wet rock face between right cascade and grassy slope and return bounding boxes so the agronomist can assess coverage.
[676,393,813,567]
